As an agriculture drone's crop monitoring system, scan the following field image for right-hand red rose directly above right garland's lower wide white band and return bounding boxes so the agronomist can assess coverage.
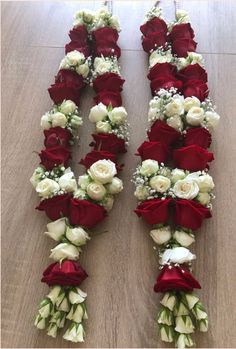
[173,144,214,172]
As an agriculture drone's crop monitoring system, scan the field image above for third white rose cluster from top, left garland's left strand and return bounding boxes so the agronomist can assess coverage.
[41,99,83,132]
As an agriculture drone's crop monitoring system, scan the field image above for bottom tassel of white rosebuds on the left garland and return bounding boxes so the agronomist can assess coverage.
[35,286,88,343]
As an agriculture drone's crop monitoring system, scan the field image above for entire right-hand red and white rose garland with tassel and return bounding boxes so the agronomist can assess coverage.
[133,7,220,348]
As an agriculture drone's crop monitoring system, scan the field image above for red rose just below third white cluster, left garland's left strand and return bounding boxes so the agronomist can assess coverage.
[43,126,72,148]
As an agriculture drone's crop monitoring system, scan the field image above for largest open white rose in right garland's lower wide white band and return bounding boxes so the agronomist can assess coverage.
[173,179,199,200]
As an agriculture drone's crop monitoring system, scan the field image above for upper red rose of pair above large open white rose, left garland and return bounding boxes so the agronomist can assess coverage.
[90,133,127,154]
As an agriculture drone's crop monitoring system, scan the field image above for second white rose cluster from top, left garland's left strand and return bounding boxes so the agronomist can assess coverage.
[59,50,91,78]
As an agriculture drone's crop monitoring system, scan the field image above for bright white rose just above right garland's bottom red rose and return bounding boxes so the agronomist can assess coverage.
[161,247,196,265]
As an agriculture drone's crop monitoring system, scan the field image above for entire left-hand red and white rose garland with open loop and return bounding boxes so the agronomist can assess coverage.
[31,8,128,342]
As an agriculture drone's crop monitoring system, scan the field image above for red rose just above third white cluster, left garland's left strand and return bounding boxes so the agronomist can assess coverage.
[48,82,80,106]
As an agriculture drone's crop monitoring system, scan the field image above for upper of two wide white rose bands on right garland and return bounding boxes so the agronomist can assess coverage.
[148,88,220,132]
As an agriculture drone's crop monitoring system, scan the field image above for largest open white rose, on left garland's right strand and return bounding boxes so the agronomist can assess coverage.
[88,160,117,184]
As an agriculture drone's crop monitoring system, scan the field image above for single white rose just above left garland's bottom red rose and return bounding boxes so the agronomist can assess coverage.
[49,242,79,261]
